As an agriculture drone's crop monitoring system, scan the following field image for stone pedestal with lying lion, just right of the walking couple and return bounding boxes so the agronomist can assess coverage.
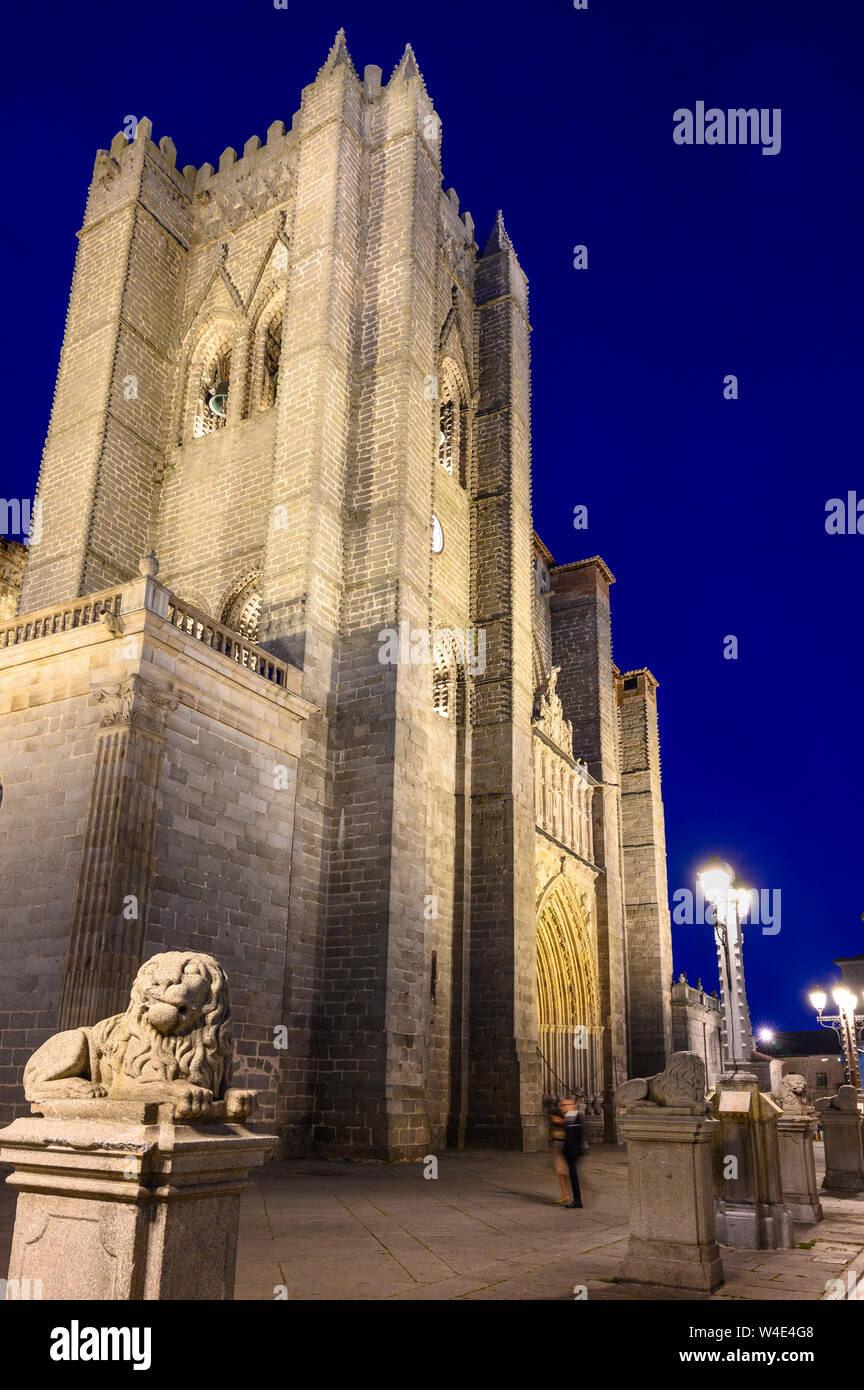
[615,1052,724,1293]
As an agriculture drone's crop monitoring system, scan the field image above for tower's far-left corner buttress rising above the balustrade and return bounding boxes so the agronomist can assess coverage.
[21,121,190,612]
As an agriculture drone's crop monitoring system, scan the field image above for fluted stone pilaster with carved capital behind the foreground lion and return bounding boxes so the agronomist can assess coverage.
[60,676,178,1029]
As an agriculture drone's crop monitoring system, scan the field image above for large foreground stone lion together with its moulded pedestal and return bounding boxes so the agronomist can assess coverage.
[0,952,276,1301]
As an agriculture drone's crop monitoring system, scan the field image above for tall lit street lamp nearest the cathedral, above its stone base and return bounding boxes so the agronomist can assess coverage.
[699,855,753,1080]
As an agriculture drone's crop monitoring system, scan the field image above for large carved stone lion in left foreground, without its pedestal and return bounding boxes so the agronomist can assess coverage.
[24,951,257,1120]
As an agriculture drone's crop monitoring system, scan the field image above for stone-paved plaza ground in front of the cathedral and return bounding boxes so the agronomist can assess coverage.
[0,1144,864,1301]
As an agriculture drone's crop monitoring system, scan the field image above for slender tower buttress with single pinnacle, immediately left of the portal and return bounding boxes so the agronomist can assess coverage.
[467,217,542,1148]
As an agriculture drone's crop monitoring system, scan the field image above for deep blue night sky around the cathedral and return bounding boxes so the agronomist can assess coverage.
[0,0,864,1029]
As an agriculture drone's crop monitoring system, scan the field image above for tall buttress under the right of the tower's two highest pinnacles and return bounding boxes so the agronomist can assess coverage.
[317,56,443,1158]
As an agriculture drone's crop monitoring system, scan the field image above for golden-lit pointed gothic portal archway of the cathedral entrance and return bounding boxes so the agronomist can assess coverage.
[538,873,603,1115]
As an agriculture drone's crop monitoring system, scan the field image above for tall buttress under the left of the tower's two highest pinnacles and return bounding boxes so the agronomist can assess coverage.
[256,46,367,1152]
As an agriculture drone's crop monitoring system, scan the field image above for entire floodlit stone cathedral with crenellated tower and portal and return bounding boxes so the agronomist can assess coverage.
[0,33,672,1159]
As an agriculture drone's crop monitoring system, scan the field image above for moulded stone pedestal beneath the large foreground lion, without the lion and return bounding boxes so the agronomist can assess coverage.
[0,1099,275,1301]
